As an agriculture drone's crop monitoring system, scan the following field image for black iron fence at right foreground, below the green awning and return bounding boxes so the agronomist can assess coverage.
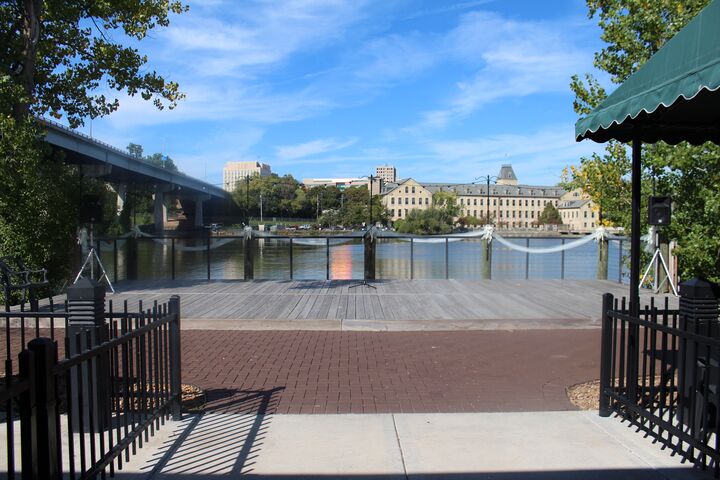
[599,282,720,478]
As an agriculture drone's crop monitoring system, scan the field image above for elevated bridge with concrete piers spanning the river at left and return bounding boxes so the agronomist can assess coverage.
[38,119,234,232]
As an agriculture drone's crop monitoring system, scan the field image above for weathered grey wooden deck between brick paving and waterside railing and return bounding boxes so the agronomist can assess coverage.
[86,280,677,330]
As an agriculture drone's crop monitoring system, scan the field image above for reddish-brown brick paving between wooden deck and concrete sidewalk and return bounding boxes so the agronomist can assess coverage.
[183,329,600,413]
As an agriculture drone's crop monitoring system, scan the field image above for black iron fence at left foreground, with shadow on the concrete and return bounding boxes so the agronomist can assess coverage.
[0,293,181,480]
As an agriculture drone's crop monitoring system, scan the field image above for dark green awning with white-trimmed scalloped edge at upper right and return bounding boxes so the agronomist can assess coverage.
[575,0,720,144]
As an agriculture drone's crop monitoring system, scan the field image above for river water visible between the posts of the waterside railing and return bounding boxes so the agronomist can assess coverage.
[100,237,629,281]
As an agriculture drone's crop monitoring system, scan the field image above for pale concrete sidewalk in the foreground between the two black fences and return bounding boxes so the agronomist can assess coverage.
[118,412,711,480]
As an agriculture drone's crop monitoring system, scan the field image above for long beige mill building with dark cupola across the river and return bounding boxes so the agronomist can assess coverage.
[383,165,566,228]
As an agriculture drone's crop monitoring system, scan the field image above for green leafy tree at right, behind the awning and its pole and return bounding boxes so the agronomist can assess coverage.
[566,0,720,281]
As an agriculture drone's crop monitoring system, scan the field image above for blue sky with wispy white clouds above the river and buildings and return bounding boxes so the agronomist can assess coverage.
[83,0,607,189]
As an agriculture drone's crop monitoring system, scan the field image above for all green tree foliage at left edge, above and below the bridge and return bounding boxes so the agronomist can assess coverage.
[0,0,186,292]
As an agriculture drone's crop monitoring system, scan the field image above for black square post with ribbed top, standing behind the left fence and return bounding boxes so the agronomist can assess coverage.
[65,278,110,429]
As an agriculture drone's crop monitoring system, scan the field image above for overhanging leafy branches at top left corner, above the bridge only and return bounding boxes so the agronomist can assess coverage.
[0,0,187,127]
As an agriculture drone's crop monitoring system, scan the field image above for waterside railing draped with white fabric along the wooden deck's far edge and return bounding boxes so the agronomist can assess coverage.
[96,234,629,282]
